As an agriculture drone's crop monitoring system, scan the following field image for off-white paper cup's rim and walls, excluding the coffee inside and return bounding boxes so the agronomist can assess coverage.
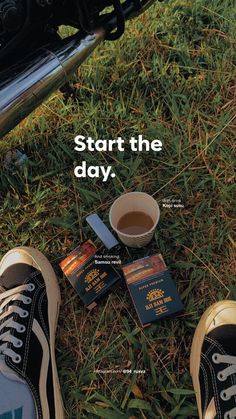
[109,192,160,247]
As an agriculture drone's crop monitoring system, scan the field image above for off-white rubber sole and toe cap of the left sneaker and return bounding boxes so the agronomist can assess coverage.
[0,247,65,419]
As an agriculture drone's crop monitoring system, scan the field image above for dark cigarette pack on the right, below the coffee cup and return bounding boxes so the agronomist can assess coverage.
[122,254,183,326]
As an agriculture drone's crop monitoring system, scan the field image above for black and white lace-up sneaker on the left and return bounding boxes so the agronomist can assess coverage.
[0,247,64,419]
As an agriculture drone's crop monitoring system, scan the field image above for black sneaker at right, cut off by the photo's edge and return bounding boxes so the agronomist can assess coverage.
[190,301,236,419]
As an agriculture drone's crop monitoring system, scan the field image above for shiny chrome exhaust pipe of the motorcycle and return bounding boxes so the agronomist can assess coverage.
[0,30,105,138]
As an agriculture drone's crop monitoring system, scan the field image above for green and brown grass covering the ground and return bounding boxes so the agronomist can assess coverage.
[0,0,236,419]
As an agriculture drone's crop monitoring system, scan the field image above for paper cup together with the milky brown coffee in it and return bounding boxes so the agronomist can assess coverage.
[109,192,160,248]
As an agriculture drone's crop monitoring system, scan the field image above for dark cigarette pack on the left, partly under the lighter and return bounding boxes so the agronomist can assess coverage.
[60,240,120,309]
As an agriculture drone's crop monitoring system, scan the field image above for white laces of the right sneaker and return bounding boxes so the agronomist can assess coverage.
[212,353,236,419]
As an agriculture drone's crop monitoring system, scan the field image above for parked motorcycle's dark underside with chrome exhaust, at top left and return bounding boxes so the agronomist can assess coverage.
[0,0,159,138]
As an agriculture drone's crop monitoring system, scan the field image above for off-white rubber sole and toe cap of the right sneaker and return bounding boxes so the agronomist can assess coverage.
[190,300,236,419]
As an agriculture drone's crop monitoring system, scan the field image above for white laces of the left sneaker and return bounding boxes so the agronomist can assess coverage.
[0,283,35,363]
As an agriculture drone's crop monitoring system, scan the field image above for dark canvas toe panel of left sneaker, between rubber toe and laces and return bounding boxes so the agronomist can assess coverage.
[0,263,37,292]
